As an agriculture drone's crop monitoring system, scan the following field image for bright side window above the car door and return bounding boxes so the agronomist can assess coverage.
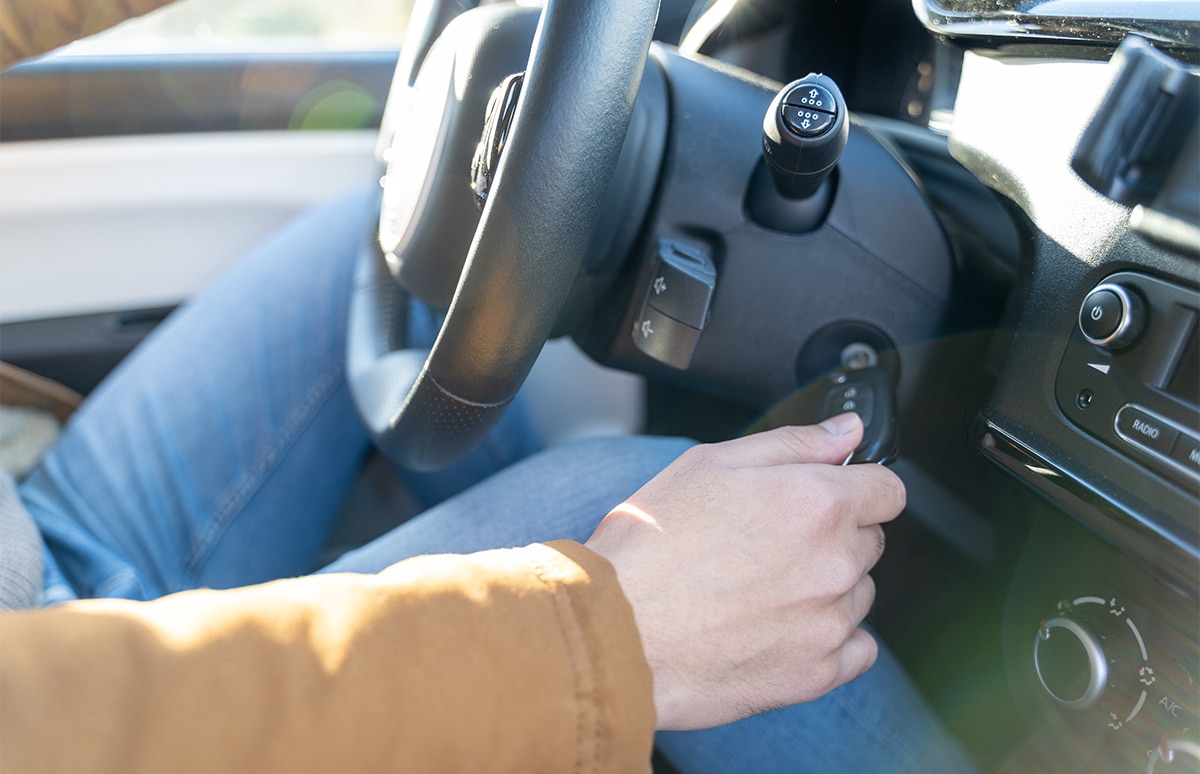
[72,0,413,54]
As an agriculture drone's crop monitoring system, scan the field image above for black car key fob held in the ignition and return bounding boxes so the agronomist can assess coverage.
[817,366,900,464]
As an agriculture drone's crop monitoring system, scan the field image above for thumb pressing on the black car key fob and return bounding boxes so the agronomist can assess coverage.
[715,413,863,467]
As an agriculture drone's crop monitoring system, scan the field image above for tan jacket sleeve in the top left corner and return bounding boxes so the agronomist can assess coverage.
[0,0,173,70]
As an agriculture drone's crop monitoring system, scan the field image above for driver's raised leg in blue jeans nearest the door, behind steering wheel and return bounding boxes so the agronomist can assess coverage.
[22,192,549,604]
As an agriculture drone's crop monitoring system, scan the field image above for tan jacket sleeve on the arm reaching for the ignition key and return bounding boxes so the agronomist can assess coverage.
[0,541,654,774]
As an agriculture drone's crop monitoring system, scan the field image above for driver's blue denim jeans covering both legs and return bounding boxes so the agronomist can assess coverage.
[20,188,968,772]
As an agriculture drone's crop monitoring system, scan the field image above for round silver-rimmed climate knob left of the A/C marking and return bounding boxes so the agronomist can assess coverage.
[1033,616,1109,709]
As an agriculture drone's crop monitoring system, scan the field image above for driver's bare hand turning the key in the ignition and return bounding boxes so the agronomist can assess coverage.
[587,414,905,731]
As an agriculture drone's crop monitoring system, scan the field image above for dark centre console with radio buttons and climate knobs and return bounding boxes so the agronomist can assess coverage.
[952,28,1200,772]
